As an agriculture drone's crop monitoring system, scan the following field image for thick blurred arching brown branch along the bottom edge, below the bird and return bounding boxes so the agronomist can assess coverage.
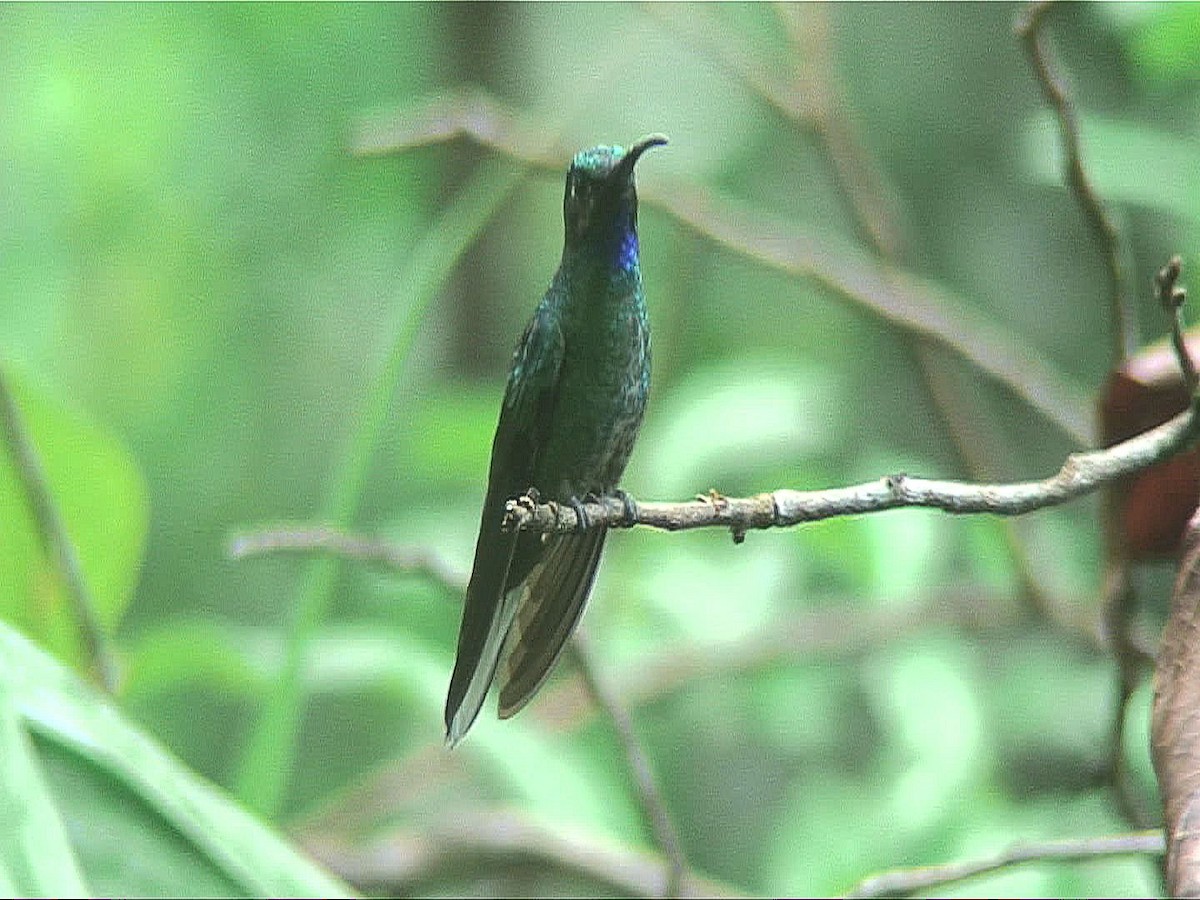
[301,814,743,896]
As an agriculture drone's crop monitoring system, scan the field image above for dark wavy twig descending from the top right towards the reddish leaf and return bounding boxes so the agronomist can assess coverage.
[1016,0,1136,366]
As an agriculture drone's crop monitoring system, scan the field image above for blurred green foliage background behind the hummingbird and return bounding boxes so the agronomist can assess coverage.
[0,4,1200,895]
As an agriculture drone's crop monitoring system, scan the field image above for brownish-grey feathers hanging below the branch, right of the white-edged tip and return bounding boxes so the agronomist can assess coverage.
[500,528,607,719]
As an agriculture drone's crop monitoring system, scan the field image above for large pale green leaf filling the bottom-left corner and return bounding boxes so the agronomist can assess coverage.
[0,624,350,896]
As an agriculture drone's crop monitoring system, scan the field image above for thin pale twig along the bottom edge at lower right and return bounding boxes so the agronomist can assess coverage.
[846,832,1164,898]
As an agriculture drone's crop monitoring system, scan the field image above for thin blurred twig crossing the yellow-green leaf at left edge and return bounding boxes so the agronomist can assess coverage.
[0,370,116,692]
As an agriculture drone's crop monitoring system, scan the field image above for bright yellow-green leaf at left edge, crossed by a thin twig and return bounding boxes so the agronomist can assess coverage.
[0,367,149,665]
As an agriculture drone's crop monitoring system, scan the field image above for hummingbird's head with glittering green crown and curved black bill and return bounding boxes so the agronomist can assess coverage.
[563,134,667,245]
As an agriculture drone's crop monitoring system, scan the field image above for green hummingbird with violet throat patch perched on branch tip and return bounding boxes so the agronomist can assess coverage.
[445,134,667,746]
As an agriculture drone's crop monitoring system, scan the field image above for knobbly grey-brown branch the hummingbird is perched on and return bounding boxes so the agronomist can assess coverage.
[504,400,1200,541]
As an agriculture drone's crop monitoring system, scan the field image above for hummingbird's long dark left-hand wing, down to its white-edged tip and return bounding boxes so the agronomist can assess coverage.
[445,303,563,745]
